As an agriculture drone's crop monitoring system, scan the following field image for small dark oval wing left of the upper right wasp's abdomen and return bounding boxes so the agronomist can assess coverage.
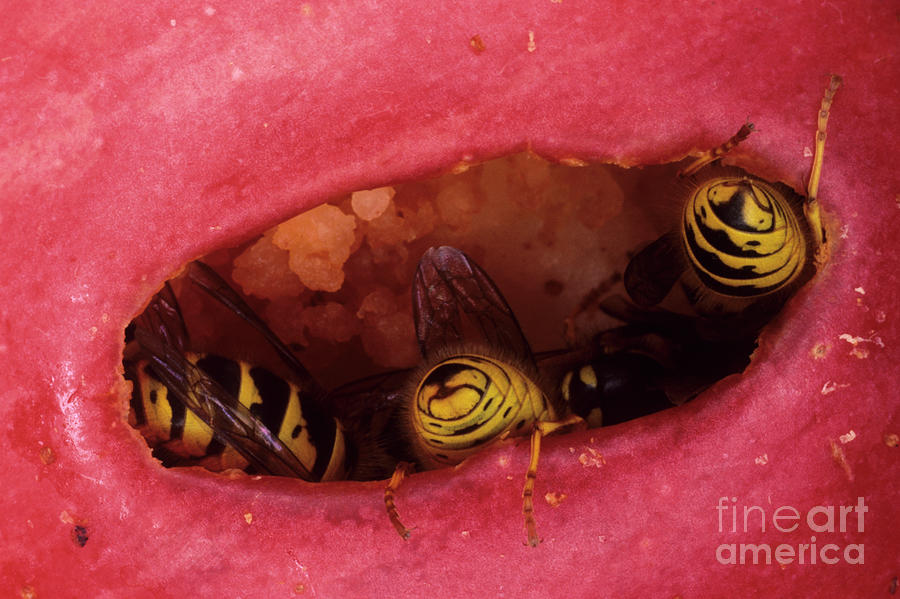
[625,232,684,306]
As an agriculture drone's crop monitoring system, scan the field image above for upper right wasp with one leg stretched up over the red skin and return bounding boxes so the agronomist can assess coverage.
[624,75,841,336]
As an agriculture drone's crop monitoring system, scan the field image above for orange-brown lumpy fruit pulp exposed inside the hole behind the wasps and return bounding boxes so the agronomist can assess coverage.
[182,153,680,388]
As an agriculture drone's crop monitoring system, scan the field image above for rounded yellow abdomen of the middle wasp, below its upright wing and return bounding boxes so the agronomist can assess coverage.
[412,355,550,464]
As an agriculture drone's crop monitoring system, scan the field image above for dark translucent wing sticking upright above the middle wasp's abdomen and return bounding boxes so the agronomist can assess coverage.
[412,246,534,366]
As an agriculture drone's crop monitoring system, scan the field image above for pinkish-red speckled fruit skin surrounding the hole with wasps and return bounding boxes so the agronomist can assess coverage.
[0,0,900,598]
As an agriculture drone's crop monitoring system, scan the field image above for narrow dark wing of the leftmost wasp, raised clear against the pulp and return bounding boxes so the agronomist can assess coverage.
[188,262,324,397]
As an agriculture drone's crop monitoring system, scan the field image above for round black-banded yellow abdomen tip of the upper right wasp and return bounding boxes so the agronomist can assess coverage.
[683,177,807,297]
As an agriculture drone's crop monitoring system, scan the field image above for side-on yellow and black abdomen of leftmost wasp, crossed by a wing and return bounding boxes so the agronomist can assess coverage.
[126,353,347,481]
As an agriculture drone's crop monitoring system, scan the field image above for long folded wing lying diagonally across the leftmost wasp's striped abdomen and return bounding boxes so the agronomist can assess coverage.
[135,328,313,480]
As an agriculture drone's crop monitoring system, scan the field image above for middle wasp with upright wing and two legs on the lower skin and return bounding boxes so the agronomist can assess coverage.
[385,246,577,545]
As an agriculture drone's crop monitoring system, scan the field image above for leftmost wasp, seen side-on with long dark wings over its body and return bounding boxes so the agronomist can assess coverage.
[125,262,394,482]
